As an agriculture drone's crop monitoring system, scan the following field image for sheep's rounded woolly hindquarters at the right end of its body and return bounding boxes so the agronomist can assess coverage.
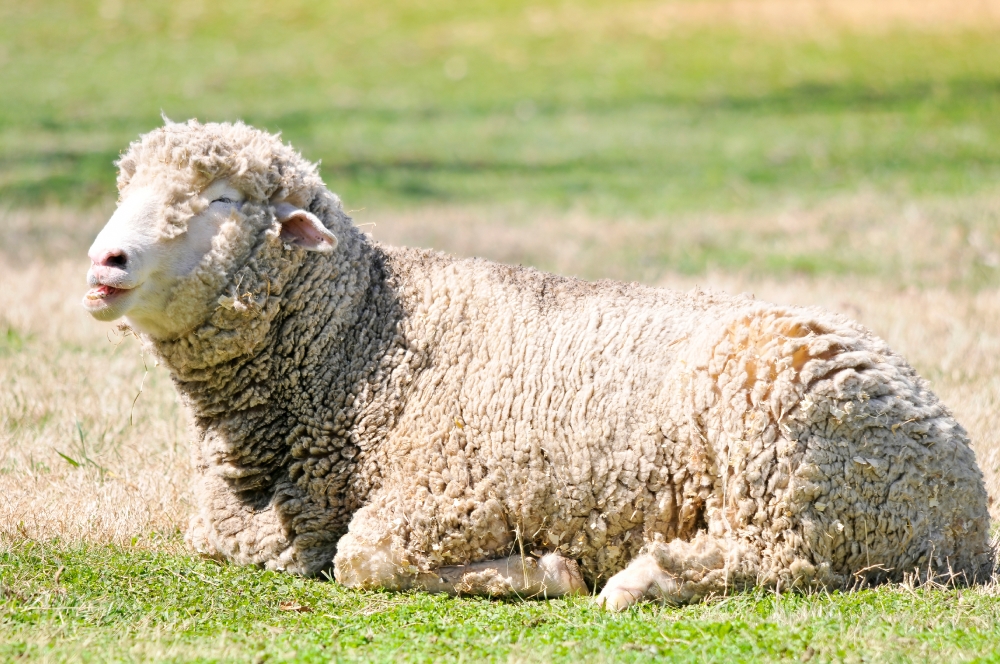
[680,307,994,601]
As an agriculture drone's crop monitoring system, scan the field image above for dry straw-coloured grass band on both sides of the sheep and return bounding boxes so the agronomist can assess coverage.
[0,199,1000,544]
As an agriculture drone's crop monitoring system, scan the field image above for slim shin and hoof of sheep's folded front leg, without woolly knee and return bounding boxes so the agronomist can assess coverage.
[414,553,587,597]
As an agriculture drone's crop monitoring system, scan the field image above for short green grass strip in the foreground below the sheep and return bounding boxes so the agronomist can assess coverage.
[0,542,1000,662]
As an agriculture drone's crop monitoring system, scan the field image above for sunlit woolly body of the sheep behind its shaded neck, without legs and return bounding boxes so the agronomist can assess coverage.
[350,249,991,587]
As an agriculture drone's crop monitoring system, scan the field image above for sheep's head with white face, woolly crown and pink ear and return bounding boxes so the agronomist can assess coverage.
[83,121,340,338]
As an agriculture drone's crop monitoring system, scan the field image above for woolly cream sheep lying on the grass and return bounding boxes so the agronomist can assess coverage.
[84,120,993,610]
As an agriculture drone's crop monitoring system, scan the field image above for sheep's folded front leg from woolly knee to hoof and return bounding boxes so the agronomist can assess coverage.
[334,533,587,597]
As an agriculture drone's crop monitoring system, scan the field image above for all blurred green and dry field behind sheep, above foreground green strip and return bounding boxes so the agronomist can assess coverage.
[0,0,1000,541]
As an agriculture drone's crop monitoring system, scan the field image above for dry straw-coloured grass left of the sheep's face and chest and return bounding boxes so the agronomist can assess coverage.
[0,210,188,544]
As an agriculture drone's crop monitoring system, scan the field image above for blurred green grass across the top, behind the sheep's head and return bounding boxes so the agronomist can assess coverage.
[0,0,1000,216]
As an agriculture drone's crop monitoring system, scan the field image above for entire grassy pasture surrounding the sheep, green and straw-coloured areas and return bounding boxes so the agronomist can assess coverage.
[0,0,1000,662]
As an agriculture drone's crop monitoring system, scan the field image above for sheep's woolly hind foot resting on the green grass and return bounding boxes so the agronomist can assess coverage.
[597,533,748,611]
